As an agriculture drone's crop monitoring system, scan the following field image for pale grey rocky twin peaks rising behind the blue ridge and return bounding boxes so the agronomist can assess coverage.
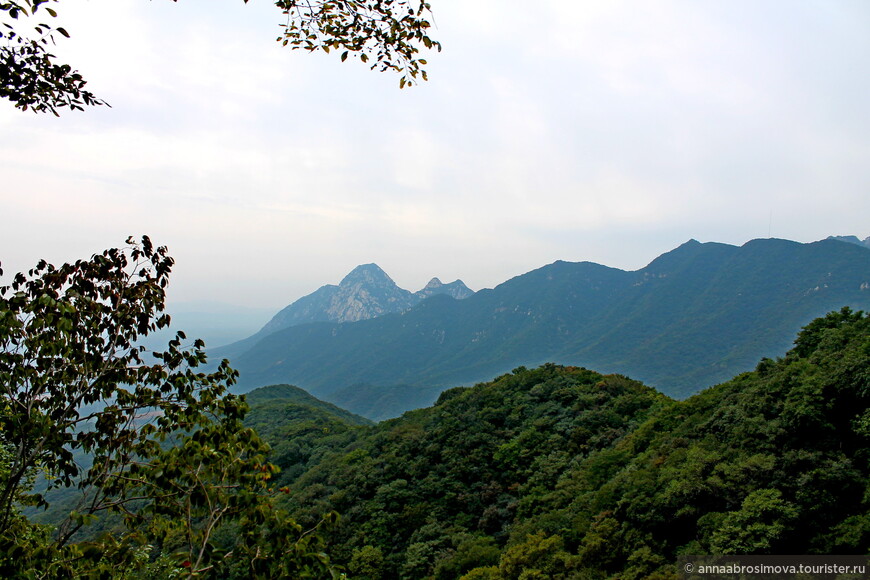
[258,264,474,334]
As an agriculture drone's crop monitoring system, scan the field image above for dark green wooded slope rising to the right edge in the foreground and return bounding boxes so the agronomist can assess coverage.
[488,308,870,578]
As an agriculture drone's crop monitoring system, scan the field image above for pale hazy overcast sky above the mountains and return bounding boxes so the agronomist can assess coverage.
[0,0,870,309]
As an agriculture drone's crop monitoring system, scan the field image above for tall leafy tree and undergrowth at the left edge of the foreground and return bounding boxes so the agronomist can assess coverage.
[0,237,332,578]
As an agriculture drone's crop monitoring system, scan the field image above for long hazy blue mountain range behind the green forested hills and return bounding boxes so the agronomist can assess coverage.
[211,239,870,419]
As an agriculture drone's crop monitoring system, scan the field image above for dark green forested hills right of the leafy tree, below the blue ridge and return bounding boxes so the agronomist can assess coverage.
[253,309,870,579]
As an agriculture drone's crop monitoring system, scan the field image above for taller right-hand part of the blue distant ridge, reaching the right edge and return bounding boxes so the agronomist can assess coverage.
[555,240,870,397]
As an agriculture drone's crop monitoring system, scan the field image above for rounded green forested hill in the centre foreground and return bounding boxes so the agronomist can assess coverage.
[270,365,666,579]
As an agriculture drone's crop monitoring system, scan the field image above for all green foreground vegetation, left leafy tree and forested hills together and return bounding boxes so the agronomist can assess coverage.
[0,238,870,580]
